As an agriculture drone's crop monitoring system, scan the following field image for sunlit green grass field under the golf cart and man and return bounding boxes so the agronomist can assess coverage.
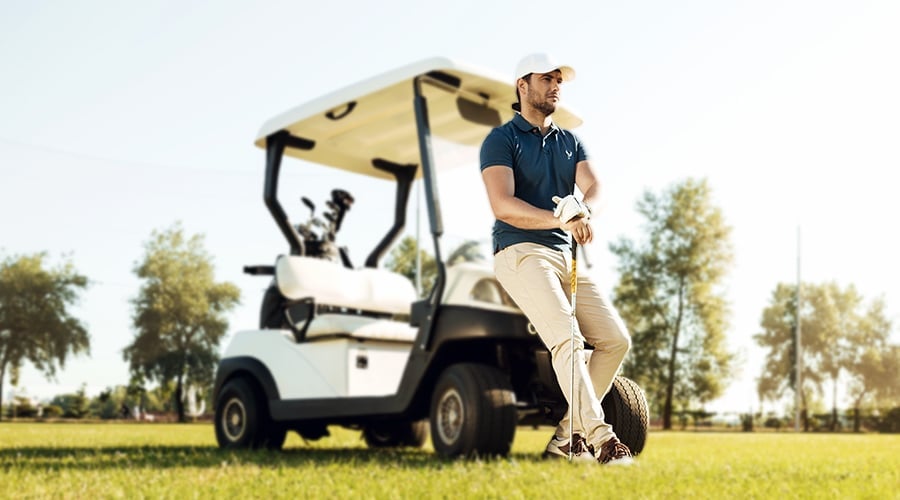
[0,423,900,499]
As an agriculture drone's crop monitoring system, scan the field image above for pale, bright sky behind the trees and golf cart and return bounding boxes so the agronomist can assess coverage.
[0,0,900,412]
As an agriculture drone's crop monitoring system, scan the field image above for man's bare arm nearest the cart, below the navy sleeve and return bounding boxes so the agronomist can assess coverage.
[481,165,560,229]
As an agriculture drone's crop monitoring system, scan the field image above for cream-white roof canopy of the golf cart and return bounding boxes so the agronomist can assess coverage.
[256,58,581,178]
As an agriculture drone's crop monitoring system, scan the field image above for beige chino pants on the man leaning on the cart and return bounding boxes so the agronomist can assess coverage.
[494,243,631,449]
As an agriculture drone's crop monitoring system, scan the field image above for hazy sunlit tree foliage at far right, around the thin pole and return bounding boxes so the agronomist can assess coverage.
[754,282,898,429]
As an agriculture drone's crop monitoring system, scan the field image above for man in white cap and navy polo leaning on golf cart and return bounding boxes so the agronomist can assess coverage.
[481,54,632,464]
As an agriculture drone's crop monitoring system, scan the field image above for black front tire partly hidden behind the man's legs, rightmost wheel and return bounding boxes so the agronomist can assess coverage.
[601,377,650,455]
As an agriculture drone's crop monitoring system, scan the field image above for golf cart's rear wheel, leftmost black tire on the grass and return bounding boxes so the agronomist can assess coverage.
[215,378,287,449]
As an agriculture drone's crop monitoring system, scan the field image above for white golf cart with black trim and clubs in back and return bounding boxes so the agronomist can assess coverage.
[213,58,648,457]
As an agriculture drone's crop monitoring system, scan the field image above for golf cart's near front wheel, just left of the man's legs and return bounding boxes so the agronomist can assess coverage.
[431,363,517,457]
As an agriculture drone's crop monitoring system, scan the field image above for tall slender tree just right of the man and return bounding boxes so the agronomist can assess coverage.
[610,179,733,429]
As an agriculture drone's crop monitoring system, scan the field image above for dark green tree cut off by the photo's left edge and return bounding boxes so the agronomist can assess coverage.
[0,253,90,420]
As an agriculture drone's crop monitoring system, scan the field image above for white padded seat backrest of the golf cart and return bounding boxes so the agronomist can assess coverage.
[275,255,416,314]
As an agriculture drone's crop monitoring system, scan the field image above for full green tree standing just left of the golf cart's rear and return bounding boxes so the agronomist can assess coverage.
[123,223,240,422]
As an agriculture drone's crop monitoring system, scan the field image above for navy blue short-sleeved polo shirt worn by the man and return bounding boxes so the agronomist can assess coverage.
[481,113,587,253]
